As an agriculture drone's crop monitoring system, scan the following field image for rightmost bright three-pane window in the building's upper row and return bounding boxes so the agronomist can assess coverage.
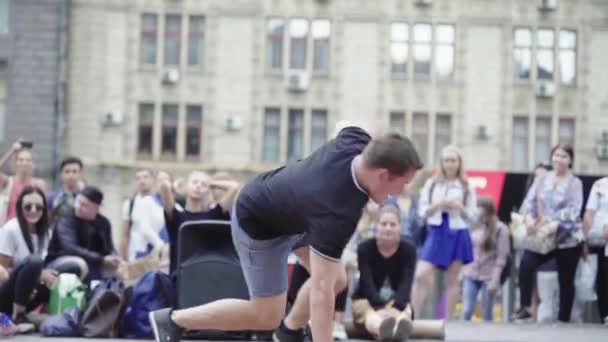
[513,27,576,85]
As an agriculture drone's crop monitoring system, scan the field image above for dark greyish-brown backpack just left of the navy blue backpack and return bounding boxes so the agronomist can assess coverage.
[80,279,126,338]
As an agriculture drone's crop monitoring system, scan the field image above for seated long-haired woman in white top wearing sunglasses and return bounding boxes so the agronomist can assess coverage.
[0,186,56,333]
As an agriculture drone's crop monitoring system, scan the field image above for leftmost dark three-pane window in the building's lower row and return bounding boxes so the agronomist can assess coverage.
[137,103,203,159]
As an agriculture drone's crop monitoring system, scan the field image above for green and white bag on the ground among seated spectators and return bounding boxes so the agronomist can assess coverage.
[49,273,87,315]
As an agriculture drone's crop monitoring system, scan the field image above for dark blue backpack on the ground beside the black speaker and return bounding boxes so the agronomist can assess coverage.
[120,271,175,338]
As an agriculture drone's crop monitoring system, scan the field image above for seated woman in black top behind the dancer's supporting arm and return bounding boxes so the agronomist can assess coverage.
[352,204,416,341]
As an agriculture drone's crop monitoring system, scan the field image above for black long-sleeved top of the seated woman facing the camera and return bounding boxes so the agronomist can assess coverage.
[353,239,416,310]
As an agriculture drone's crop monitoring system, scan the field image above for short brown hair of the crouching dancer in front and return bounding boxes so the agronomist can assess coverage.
[363,133,423,175]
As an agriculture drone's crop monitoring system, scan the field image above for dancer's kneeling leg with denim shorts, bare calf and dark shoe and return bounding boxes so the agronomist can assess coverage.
[150,207,293,342]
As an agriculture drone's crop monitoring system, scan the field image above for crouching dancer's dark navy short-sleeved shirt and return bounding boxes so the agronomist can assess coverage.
[236,127,371,260]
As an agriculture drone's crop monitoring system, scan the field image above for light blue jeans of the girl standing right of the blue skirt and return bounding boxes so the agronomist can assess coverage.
[462,277,496,322]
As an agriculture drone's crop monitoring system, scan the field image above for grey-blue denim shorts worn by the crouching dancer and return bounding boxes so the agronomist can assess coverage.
[230,208,306,298]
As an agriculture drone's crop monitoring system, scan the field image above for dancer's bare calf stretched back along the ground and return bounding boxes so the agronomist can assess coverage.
[171,292,287,330]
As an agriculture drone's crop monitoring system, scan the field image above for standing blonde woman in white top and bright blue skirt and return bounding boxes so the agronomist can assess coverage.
[412,145,477,319]
